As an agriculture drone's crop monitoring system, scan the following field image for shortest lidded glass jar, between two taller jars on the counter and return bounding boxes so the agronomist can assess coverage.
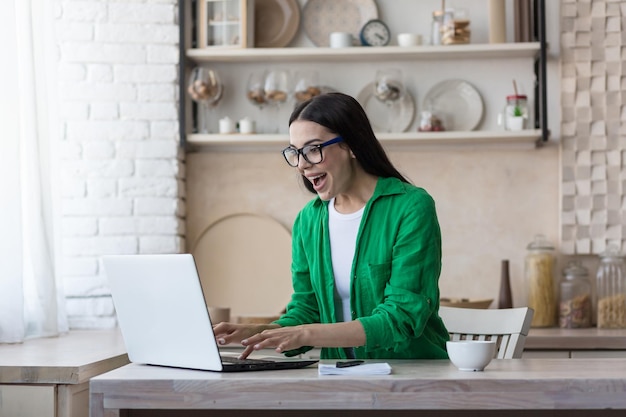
[559,260,591,329]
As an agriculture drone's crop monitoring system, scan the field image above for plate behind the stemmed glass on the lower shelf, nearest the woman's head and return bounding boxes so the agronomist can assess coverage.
[356,81,415,132]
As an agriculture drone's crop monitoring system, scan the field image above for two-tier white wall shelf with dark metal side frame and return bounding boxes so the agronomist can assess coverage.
[180,0,549,151]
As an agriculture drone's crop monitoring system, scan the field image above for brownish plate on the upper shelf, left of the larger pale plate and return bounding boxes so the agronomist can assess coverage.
[254,0,300,48]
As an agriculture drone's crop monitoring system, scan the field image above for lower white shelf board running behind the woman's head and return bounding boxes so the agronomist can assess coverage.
[187,129,541,151]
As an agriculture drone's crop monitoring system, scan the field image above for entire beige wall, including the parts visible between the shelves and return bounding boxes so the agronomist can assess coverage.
[186,0,561,316]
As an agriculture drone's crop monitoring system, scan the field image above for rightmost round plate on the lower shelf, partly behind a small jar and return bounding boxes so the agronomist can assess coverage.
[422,80,483,131]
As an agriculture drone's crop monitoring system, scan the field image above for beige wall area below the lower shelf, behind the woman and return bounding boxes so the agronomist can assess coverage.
[187,146,559,312]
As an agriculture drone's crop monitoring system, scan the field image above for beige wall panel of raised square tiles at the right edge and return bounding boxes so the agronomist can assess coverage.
[561,0,626,254]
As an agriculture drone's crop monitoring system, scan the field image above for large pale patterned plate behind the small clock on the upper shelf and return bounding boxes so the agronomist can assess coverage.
[302,0,378,46]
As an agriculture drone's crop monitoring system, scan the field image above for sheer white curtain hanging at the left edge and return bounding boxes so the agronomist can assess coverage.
[0,0,68,343]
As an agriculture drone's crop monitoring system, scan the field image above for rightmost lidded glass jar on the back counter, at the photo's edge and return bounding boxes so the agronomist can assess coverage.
[596,246,626,329]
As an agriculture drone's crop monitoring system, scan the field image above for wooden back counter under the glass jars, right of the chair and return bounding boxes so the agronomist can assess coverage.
[524,327,626,351]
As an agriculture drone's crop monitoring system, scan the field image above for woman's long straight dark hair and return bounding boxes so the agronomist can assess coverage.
[289,93,409,194]
